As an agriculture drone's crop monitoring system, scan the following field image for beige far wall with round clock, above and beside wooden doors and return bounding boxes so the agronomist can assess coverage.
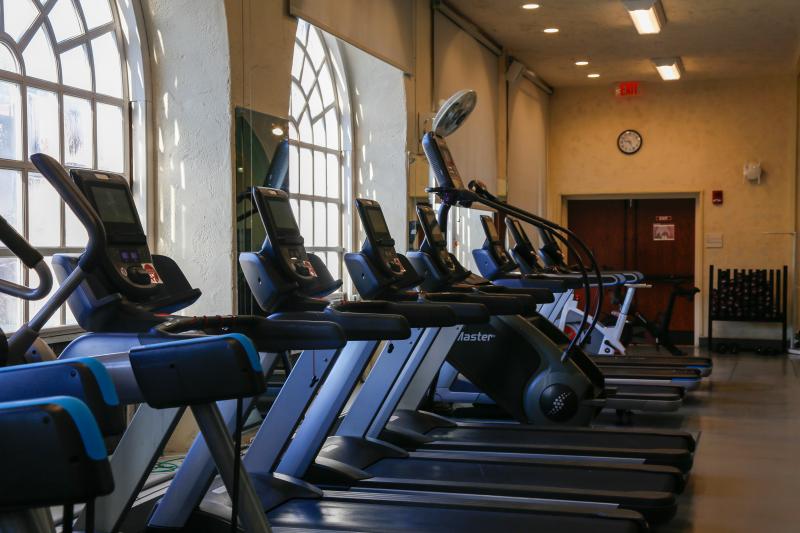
[548,76,797,334]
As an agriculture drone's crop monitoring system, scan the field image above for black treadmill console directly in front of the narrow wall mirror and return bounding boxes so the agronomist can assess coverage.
[253,187,318,284]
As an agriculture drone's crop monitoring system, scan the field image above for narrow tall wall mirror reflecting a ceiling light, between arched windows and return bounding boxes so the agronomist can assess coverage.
[235,107,289,314]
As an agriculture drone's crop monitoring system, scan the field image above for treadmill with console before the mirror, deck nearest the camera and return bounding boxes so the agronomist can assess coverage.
[136,185,646,532]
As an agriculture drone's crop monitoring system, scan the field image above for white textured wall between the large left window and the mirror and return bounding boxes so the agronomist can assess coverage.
[143,0,233,314]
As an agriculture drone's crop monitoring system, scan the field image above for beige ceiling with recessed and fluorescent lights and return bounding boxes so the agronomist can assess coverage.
[449,0,800,87]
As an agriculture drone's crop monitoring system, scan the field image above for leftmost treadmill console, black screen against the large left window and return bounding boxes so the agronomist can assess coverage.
[71,170,164,296]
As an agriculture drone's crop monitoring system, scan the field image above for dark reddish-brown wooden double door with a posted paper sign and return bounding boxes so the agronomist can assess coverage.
[567,198,695,344]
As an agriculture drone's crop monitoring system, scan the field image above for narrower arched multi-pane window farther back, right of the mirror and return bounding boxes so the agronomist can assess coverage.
[289,20,346,277]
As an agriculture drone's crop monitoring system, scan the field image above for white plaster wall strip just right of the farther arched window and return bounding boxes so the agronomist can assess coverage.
[340,43,408,253]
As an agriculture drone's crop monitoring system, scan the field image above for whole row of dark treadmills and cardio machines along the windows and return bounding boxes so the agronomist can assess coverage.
[0,92,711,533]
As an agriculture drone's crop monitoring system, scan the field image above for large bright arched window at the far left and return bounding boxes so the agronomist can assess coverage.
[0,0,129,330]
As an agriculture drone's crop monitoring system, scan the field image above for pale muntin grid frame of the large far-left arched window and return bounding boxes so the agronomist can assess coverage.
[0,0,131,335]
